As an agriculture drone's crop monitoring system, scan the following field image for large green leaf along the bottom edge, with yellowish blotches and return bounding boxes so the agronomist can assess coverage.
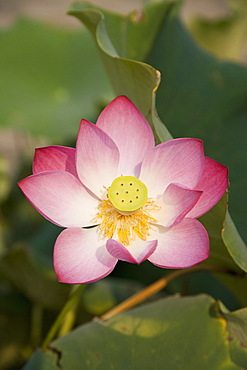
[25,295,240,370]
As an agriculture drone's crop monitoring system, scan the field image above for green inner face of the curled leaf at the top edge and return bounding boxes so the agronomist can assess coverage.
[69,0,174,61]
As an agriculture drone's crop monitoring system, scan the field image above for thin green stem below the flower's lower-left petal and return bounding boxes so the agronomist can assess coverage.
[42,284,86,351]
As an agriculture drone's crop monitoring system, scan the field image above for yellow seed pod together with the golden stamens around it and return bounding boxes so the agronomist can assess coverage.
[95,176,159,246]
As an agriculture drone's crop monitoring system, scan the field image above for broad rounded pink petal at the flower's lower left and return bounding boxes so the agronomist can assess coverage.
[54,228,117,284]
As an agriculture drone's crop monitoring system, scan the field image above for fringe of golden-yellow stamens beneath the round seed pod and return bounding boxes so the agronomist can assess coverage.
[96,199,158,246]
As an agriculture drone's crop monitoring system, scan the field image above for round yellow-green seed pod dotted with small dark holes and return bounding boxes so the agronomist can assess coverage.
[108,176,148,213]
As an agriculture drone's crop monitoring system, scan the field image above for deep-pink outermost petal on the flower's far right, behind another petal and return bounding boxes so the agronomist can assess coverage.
[187,157,228,218]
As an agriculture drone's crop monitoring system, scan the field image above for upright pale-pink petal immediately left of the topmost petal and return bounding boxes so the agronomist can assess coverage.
[76,120,119,197]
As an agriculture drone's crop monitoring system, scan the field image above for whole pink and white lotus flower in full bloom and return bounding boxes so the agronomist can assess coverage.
[19,96,228,284]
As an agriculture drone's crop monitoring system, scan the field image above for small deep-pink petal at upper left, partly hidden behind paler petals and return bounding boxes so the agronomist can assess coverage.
[33,146,77,177]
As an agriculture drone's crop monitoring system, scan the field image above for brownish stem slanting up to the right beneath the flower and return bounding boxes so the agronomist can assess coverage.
[100,265,234,320]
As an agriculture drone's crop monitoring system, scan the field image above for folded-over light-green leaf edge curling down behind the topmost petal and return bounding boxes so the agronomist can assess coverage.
[68,2,172,141]
